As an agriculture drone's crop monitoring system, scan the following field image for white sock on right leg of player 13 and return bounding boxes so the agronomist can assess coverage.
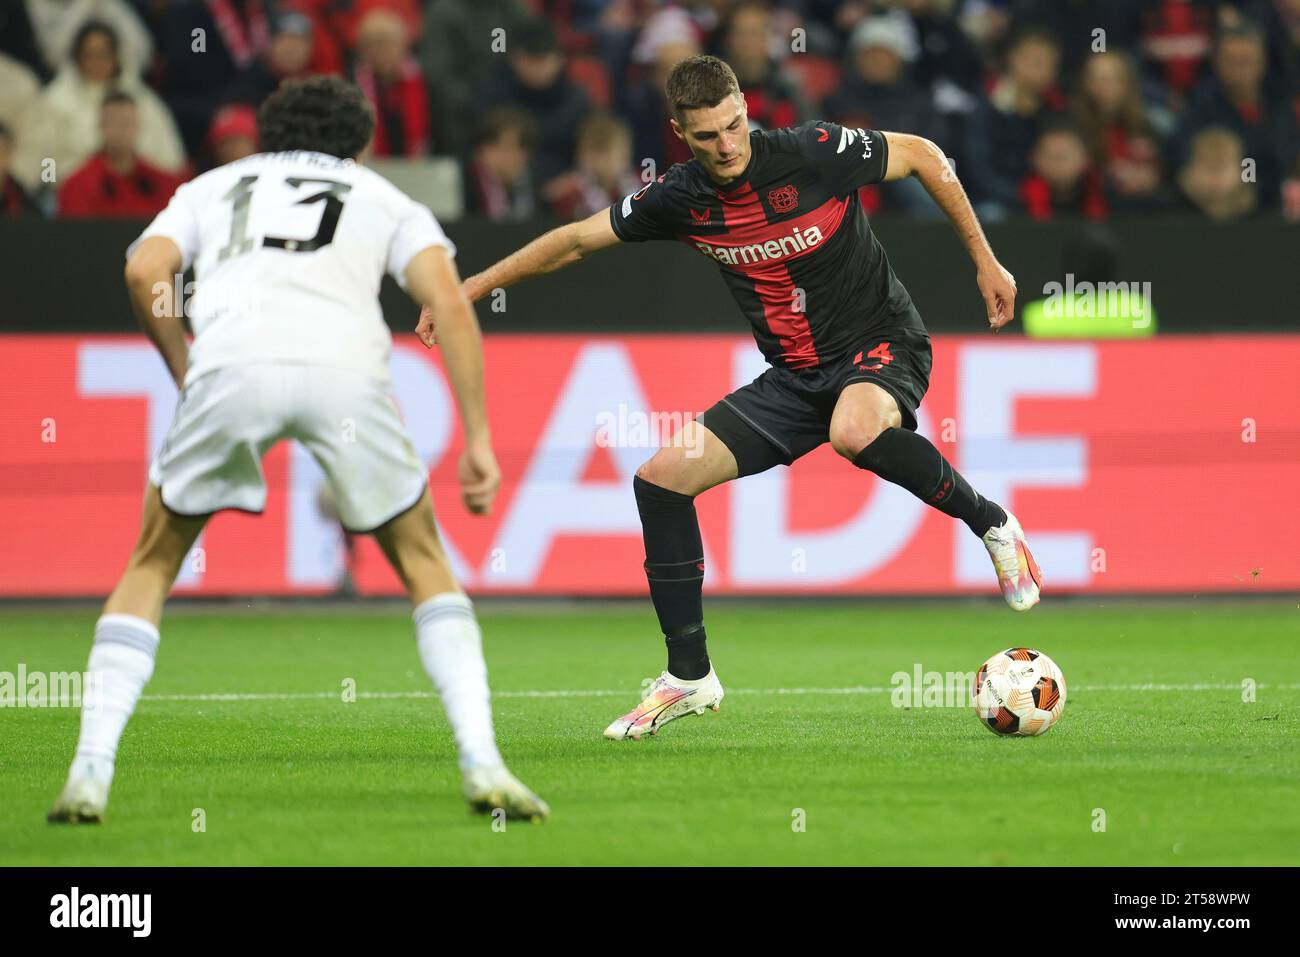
[412,592,503,770]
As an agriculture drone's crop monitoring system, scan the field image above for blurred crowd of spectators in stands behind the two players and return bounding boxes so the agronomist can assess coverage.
[0,0,1300,221]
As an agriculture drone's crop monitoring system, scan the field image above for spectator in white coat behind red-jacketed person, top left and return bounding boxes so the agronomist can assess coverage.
[13,22,186,191]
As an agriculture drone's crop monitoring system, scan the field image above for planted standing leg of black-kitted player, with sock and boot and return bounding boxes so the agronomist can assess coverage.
[605,420,737,740]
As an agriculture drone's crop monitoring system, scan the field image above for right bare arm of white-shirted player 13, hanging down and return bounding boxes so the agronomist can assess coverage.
[406,246,501,515]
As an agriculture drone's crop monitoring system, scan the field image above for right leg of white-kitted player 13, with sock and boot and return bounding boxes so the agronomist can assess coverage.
[374,492,550,820]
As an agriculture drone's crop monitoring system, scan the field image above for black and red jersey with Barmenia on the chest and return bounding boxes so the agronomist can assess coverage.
[610,122,924,369]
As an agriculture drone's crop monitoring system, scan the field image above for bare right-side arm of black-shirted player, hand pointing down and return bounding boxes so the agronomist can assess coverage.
[884,133,1015,332]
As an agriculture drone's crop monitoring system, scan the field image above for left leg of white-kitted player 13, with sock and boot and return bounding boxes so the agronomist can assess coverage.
[47,485,207,823]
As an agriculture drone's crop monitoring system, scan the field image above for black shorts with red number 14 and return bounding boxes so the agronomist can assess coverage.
[699,326,932,477]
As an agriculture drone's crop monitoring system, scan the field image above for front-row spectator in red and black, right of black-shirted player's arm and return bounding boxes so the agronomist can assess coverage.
[1021,116,1109,222]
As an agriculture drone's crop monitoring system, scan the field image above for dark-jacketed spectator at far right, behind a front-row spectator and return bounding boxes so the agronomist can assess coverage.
[1171,25,1300,208]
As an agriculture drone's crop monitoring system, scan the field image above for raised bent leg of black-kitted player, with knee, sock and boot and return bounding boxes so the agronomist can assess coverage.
[831,382,1043,611]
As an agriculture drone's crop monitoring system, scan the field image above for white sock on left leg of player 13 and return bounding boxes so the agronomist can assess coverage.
[69,614,159,783]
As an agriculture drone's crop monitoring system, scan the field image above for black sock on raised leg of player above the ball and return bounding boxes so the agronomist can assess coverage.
[853,429,1006,537]
